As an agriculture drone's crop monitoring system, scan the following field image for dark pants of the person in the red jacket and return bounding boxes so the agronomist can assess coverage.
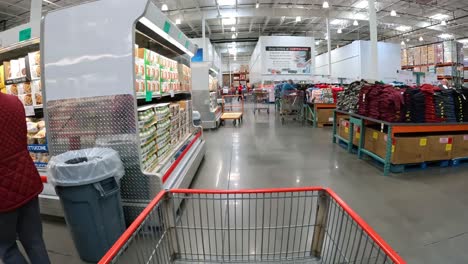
[0,197,50,264]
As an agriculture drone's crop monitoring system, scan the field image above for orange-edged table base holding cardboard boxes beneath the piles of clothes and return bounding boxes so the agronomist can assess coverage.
[333,110,468,175]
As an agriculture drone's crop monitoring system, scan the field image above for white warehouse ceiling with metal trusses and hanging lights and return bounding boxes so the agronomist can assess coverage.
[0,0,468,55]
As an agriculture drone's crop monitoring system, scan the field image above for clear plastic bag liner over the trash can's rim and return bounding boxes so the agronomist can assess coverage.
[47,148,125,186]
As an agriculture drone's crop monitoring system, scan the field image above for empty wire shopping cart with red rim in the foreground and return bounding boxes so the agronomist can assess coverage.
[99,187,406,264]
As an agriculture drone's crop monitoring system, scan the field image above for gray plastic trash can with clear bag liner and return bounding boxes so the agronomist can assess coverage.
[48,148,125,262]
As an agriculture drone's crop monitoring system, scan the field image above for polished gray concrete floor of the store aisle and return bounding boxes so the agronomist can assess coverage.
[44,104,468,264]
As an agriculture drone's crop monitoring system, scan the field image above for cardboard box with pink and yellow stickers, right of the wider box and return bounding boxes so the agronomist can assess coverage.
[425,135,453,161]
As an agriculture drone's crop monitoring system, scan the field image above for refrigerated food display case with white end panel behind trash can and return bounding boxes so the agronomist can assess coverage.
[41,0,205,223]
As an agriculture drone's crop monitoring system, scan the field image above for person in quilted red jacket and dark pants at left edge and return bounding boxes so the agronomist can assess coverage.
[0,93,50,264]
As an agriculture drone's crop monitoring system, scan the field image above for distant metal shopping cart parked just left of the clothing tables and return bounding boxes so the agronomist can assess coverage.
[280,90,305,124]
